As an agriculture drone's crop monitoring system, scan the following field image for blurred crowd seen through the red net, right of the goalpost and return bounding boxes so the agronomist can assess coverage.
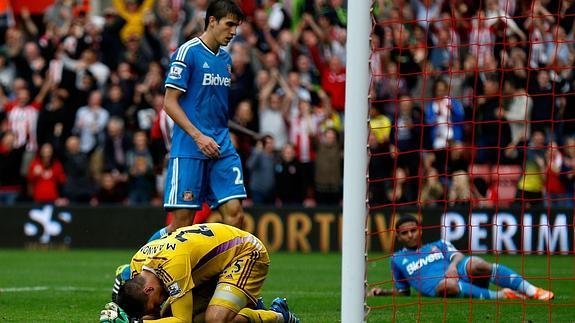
[370,0,575,208]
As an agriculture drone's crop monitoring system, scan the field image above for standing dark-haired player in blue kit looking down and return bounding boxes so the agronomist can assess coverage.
[153,0,246,240]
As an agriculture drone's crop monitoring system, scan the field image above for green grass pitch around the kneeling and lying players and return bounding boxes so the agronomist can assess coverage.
[0,250,575,323]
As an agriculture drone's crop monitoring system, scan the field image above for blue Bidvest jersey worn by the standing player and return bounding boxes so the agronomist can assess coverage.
[165,37,235,158]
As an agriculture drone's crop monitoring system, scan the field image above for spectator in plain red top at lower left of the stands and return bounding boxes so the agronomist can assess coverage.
[28,143,66,203]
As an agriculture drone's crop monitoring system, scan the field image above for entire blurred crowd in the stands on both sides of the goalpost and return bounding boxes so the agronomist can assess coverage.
[0,0,575,209]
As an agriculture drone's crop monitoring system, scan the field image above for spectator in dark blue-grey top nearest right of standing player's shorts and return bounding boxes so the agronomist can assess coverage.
[246,135,276,205]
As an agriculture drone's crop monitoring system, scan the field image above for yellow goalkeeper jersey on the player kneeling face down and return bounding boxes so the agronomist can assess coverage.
[130,223,269,303]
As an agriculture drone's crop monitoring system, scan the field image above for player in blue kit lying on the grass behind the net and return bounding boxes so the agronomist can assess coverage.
[370,215,554,301]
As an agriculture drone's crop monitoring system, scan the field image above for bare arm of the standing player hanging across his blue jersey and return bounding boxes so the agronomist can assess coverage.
[164,86,220,158]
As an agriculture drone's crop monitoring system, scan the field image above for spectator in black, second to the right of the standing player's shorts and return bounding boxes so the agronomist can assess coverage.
[275,144,306,206]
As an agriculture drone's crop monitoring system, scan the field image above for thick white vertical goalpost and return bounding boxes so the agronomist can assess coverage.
[341,0,372,323]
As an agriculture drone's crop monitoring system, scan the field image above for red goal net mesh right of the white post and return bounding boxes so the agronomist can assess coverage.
[367,0,575,322]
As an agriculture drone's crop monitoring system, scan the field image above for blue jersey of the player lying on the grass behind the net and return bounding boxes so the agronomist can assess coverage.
[391,240,458,296]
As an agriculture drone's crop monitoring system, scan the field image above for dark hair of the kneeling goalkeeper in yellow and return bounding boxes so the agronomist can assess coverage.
[116,275,148,318]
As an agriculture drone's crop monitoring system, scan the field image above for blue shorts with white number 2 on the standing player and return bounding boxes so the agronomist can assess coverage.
[164,154,247,210]
